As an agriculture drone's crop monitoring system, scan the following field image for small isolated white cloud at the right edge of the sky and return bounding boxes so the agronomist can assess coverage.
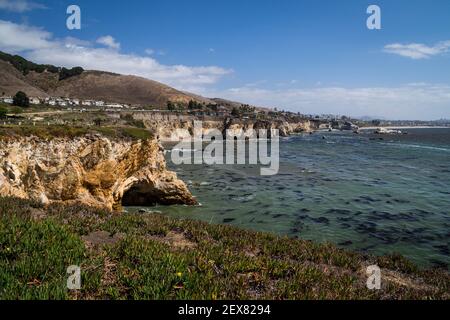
[384,40,450,60]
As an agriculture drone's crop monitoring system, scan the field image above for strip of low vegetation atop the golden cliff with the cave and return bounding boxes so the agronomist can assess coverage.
[0,125,153,140]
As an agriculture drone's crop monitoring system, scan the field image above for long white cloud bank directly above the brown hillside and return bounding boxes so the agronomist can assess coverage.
[0,20,232,90]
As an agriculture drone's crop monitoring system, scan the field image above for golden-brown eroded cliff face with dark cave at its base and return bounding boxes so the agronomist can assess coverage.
[0,135,197,211]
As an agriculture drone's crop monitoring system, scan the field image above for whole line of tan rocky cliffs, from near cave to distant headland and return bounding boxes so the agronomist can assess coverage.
[0,113,318,211]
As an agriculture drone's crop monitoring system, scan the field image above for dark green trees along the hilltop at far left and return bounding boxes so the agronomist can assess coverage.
[0,51,84,81]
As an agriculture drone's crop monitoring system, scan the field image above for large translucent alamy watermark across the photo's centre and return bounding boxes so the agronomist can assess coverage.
[171,121,280,176]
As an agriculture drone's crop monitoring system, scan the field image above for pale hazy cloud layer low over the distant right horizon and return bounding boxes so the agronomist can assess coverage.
[201,83,450,119]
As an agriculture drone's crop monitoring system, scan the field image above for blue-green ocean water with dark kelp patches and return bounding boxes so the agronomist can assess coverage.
[128,129,450,268]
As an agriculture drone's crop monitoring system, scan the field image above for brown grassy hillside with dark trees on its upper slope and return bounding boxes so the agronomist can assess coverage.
[0,52,212,108]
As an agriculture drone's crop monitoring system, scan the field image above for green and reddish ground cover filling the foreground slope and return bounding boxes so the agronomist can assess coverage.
[0,198,450,299]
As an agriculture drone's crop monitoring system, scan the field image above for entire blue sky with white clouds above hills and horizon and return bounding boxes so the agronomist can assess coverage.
[0,0,450,120]
